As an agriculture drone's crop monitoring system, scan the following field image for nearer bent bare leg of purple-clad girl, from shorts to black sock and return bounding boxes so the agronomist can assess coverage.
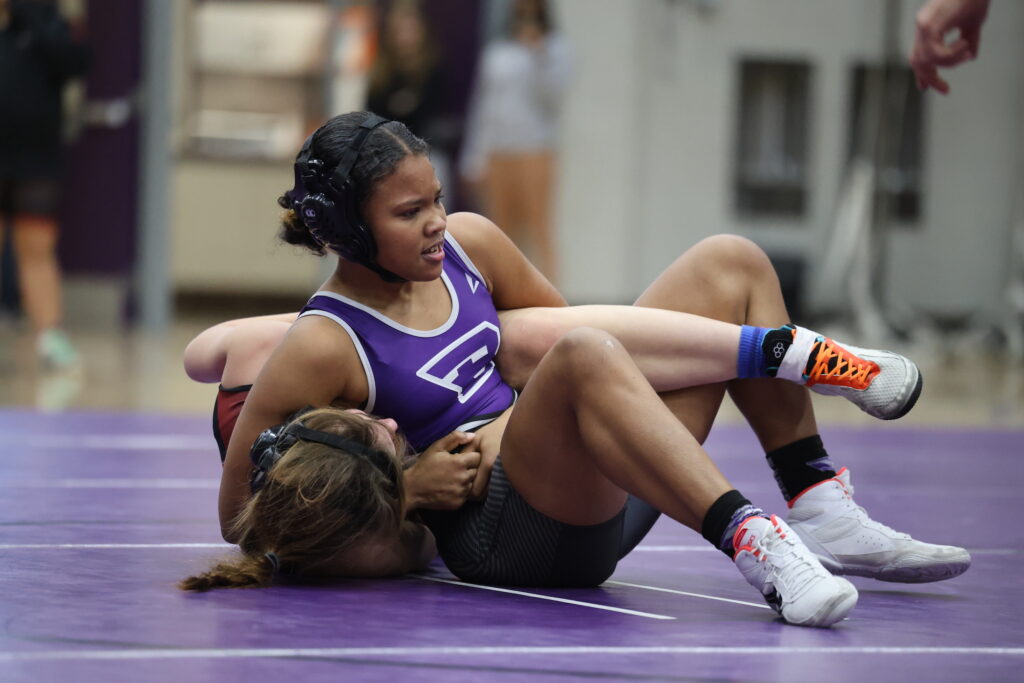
[502,329,732,530]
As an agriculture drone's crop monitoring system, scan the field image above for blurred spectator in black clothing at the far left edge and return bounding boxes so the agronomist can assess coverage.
[0,0,88,368]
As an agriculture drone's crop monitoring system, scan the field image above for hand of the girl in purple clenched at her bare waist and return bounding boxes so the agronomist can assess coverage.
[404,431,480,510]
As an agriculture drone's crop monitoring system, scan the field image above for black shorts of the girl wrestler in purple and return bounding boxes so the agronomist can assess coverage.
[423,457,626,587]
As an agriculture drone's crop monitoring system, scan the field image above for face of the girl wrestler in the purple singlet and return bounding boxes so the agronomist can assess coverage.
[364,155,447,282]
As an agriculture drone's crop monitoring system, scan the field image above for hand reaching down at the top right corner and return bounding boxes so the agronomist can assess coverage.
[910,0,988,94]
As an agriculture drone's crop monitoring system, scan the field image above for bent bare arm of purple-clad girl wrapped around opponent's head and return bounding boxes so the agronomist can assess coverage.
[218,315,368,542]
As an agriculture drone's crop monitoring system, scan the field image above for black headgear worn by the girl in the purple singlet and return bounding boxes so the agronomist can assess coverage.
[286,114,406,283]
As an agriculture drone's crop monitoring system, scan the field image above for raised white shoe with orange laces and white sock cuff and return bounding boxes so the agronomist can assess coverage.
[776,327,922,420]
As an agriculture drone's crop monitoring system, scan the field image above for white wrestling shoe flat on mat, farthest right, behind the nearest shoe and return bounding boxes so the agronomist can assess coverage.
[786,467,971,584]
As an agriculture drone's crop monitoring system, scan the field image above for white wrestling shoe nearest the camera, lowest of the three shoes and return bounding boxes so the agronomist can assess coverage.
[732,515,857,628]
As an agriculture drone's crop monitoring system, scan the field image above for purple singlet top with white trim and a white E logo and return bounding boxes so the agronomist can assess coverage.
[300,233,515,452]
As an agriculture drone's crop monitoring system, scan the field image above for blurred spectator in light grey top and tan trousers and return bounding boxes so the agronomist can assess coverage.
[462,0,569,284]
